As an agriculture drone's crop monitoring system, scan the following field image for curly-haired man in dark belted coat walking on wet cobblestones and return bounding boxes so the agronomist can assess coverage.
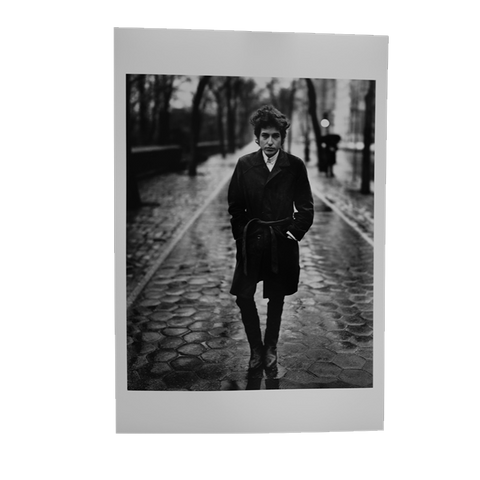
[228,105,313,369]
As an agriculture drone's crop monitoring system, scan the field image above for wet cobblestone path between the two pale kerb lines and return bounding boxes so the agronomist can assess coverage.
[127,187,373,390]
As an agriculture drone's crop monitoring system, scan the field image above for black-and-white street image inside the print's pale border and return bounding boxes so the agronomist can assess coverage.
[126,74,375,391]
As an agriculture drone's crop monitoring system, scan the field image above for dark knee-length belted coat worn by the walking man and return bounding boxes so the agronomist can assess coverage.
[228,150,313,298]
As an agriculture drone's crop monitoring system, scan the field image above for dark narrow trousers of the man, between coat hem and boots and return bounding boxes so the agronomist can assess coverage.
[236,295,285,348]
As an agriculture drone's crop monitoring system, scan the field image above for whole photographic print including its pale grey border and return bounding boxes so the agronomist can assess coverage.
[112,25,390,436]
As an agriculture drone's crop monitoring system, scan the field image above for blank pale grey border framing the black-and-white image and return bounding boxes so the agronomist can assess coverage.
[113,27,389,435]
